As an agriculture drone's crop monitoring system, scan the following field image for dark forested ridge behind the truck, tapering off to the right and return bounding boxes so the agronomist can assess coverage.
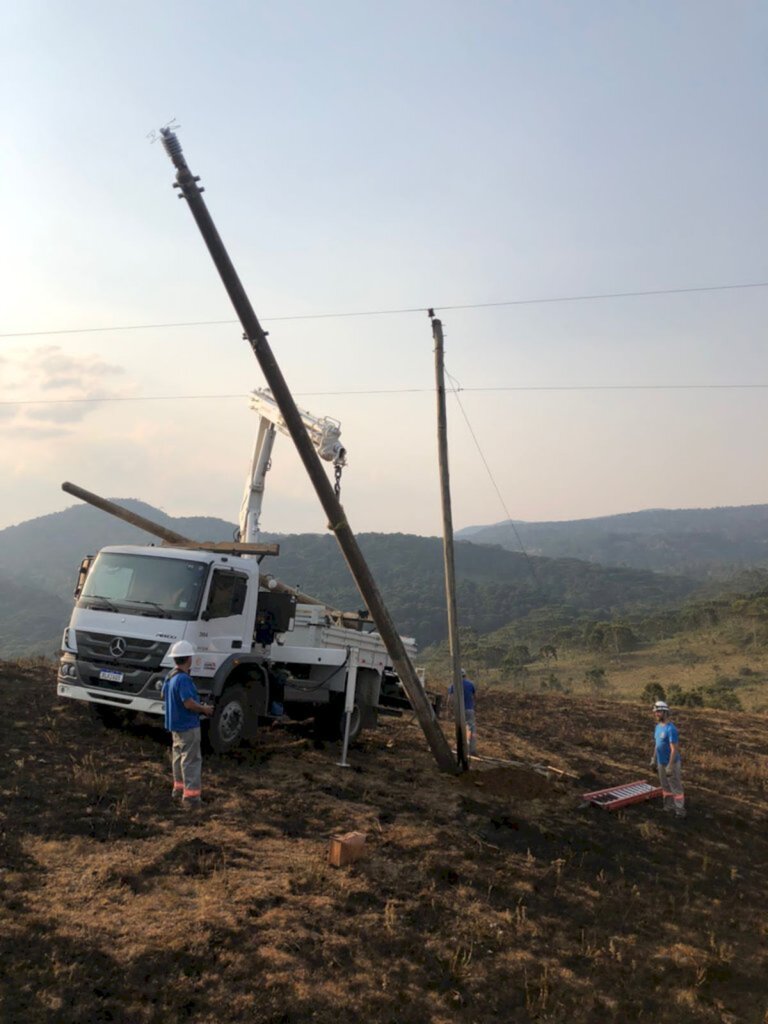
[0,500,696,653]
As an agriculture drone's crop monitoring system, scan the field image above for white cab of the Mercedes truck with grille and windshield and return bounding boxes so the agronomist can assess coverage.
[58,546,258,714]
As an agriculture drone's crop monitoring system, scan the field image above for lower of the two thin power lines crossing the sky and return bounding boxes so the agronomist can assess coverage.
[0,383,768,406]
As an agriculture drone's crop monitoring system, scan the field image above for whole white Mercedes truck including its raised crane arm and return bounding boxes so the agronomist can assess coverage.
[57,391,416,753]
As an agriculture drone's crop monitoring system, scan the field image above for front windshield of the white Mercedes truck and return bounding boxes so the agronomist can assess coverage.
[78,551,208,620]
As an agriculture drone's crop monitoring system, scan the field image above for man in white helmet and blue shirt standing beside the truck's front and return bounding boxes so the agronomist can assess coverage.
[163,640,213,810]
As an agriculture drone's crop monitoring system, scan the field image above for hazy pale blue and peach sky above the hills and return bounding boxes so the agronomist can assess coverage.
[0,0,768,535]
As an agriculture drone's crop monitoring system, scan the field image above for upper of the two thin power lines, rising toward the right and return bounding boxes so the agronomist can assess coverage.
[0,281,768,338]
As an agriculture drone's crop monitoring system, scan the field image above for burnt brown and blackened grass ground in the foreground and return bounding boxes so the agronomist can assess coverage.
[0,664,768,1024]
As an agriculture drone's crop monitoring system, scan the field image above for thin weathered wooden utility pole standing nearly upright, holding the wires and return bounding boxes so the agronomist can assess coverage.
[429,309,469,771]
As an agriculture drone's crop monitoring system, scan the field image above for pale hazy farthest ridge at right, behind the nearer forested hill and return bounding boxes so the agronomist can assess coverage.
[457,505,768,579]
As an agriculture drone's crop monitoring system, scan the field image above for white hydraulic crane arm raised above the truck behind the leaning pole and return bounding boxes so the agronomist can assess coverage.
[240,389,347,544]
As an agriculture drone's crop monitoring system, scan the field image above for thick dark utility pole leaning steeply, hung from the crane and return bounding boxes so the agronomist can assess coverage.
[160,128,455,771]
